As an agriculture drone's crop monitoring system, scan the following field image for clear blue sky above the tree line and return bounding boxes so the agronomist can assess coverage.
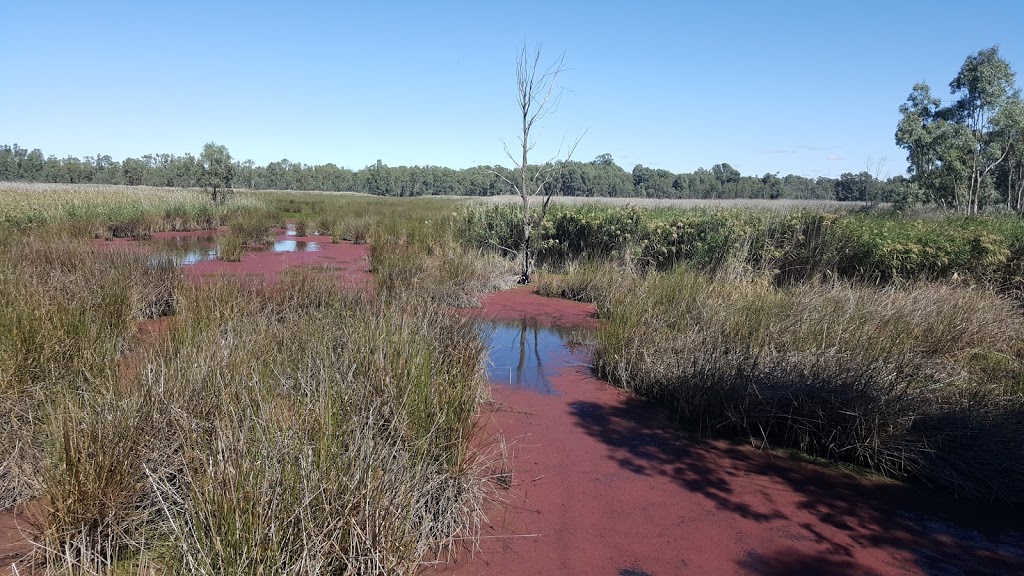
[0,0,1024,177]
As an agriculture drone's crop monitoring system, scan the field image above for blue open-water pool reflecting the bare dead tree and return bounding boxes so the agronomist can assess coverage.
[480,319,585,394]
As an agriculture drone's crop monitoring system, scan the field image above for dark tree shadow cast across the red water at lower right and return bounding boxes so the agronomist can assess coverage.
[569,397,1024,575]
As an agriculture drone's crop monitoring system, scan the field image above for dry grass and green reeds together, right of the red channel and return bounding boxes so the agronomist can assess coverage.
[524,207,1024,502]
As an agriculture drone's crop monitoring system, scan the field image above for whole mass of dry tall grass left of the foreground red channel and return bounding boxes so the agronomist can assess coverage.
[0,226,484,574]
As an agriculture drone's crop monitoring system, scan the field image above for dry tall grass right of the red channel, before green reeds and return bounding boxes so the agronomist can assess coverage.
[595,270,1024,501]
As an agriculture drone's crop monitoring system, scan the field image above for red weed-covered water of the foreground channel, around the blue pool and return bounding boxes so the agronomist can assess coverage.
[446,288,1024,576]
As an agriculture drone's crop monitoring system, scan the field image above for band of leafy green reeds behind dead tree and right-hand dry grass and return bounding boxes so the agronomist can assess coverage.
[459,205,1024,285]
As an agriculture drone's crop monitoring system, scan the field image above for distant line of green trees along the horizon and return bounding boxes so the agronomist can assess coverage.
[0,145,907,202]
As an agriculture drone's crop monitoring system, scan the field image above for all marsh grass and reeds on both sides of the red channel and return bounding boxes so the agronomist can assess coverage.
[0,184,1024,574]
